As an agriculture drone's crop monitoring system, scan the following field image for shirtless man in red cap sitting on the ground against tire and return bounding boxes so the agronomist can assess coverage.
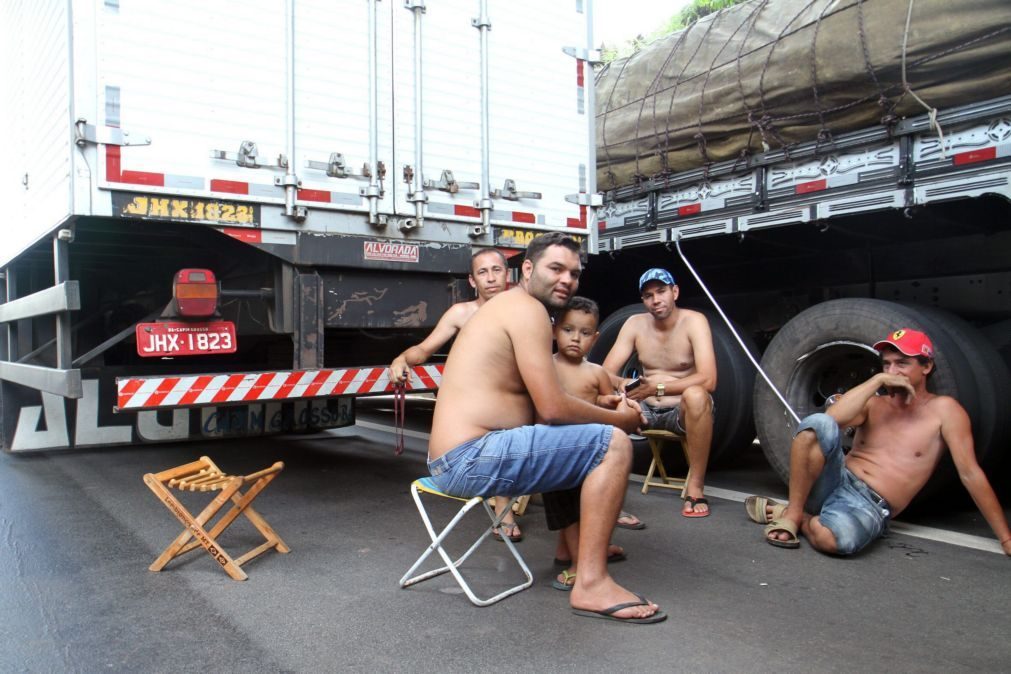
[744,328,1011,555]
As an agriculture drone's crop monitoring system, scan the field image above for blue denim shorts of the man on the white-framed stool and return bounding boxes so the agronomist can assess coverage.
[429,423,614,497]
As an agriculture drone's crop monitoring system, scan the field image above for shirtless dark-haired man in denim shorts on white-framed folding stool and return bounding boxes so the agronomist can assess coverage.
[429,232,666,622]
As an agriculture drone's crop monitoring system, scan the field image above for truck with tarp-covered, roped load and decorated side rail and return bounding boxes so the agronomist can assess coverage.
[580,0,1011,493]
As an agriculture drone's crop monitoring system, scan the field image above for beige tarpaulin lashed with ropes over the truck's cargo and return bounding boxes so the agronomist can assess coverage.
[595,0,1011,190]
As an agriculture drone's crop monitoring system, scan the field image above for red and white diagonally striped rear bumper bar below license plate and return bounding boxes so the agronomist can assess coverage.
[116,365,443,410]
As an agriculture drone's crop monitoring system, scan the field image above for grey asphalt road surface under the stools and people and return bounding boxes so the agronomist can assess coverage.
[0,401,1011,672]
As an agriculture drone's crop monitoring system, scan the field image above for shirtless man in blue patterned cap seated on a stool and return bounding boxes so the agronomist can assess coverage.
[604,268,716,517]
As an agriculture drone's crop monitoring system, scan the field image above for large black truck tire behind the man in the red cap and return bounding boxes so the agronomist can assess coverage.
[754,298,1009,503]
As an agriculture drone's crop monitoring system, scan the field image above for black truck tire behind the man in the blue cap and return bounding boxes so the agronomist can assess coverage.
[589,304,758,472]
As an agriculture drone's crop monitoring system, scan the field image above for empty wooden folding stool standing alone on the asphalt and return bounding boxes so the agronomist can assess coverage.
[144,457,290,580]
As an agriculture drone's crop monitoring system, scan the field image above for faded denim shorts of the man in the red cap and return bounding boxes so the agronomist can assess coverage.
[797,413,892,555]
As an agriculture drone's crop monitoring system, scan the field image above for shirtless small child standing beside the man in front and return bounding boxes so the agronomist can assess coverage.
[543,297,627,591]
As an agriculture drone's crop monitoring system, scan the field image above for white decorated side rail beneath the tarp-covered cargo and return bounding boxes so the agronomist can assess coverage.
[598,96,1011,252]
